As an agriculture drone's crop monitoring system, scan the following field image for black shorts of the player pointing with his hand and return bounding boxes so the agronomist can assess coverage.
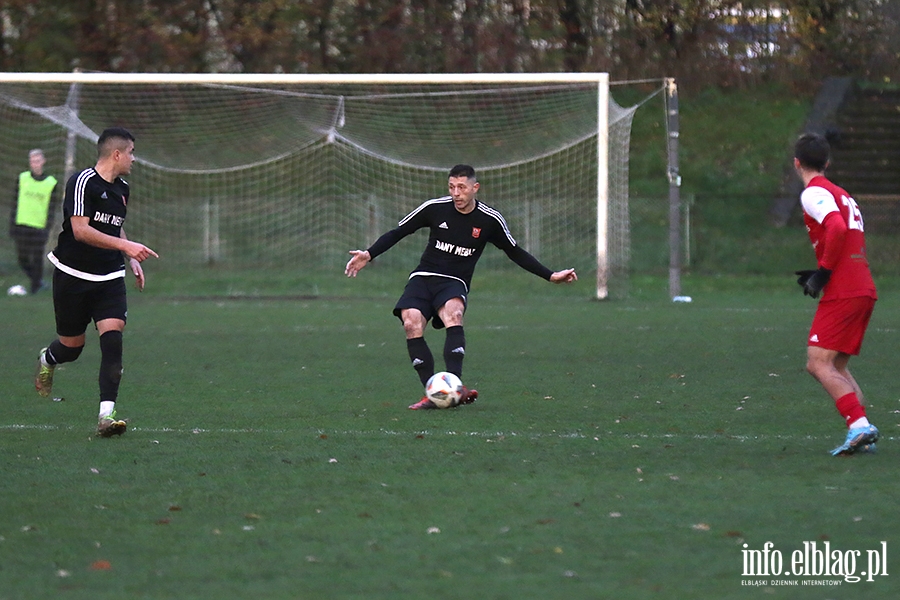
[53,269,128,336]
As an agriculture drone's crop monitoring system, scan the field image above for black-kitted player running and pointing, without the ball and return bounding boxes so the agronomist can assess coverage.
[34,127,157,437]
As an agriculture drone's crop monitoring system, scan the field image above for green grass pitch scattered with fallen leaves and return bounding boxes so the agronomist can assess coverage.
[0,270,900,600]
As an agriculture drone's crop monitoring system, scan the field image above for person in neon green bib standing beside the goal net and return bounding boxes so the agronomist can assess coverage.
[9,149,59,294]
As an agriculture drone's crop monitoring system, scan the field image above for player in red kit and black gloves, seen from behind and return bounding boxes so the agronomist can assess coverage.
[794,134,878,456]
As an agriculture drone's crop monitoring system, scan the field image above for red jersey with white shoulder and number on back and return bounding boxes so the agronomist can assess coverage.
[800,175,878,301]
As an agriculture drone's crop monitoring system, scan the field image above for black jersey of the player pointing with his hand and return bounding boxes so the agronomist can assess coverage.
[48,168,129,281]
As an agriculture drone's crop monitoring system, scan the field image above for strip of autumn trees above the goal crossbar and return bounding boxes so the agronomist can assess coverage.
[0,0,900,86]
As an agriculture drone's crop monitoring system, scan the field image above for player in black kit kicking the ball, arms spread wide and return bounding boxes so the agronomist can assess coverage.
[344,165,578,410]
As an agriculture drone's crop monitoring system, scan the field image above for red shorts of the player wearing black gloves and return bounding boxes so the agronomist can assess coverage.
[807,296,875,356]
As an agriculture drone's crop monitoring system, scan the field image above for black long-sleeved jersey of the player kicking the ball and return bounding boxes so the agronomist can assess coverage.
[368,196,553,289]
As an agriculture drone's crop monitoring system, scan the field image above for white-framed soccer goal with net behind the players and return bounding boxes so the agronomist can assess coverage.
[0,73,634,298]
